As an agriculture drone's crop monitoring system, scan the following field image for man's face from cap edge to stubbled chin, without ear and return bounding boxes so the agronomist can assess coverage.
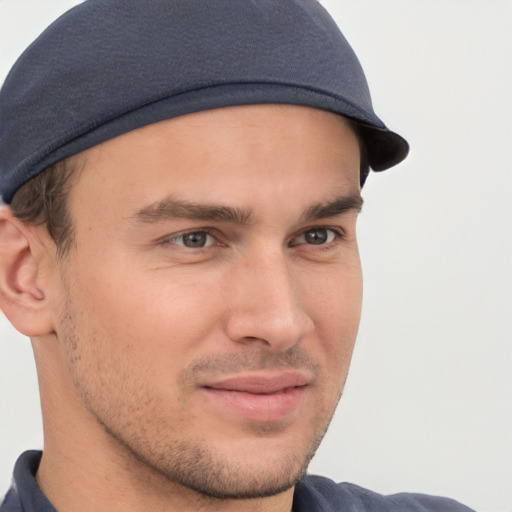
[46,105,361,497]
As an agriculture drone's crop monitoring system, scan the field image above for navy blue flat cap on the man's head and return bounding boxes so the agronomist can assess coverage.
[0,0,409,203]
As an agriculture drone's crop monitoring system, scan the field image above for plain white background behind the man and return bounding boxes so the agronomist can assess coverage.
[0,0,512,512]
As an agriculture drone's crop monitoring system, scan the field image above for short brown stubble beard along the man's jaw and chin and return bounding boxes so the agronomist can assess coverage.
[57,284,343,500]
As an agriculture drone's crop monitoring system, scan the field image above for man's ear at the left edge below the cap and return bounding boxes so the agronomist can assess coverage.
[0,206,53,337]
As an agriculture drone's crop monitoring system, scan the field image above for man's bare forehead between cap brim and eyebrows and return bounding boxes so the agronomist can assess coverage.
[71,105,360,217]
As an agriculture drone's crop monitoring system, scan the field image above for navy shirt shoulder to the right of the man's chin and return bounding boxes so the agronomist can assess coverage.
[293,475,474,512]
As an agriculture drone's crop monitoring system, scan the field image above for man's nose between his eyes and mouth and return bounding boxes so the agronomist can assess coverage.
[226,253,314,352]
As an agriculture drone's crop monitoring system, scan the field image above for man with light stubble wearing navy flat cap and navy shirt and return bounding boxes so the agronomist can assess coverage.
[0,0,476,512]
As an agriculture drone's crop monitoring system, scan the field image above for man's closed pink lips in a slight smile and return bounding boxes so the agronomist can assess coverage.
[203,372,309,423]
